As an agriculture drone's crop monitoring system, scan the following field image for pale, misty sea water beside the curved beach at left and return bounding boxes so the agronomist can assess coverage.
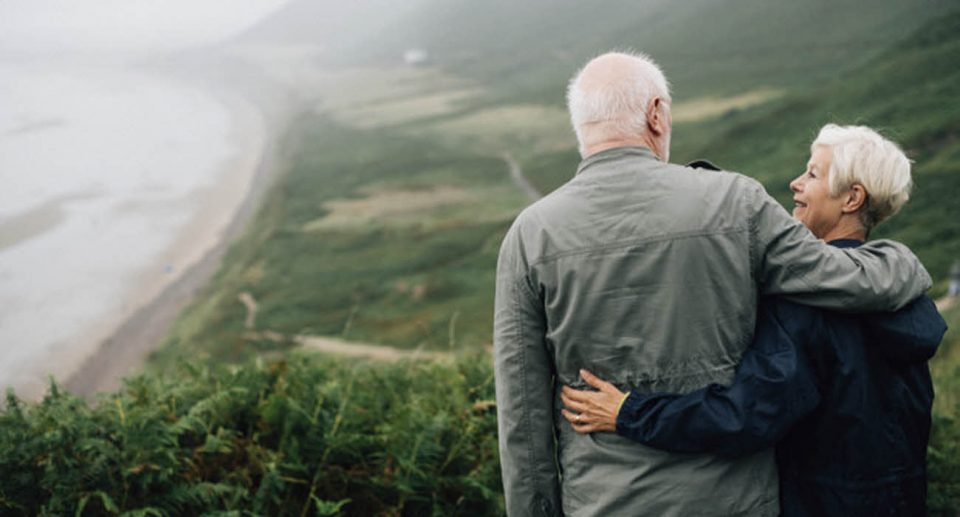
[0,63,262,394]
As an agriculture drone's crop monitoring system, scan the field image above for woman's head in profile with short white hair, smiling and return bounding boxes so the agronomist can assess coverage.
[790,124,912,240]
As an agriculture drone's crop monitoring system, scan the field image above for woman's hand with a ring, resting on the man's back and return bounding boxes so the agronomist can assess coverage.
[560,370,627,434]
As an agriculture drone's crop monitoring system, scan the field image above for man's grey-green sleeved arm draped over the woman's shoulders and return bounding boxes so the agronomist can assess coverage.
[744,179,931,306]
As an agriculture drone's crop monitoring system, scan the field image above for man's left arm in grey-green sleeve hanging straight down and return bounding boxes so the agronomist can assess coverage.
[493,223,561,515]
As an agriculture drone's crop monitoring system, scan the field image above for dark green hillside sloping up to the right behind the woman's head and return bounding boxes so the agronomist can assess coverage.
[675,13,960,293]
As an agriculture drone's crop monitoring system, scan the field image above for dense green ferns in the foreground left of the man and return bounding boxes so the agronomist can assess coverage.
[0,355,503,516]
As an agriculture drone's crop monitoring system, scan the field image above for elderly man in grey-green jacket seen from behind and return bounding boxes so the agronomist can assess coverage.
[494,53,930,516]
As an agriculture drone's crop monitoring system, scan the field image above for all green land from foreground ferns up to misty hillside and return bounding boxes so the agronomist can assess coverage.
[0,0,960,515]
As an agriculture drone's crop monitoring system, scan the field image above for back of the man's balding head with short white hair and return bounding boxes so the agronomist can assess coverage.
[567,52,670,153]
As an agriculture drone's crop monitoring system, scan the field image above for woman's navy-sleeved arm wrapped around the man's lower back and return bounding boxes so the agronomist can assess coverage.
[617,306,820,456]
